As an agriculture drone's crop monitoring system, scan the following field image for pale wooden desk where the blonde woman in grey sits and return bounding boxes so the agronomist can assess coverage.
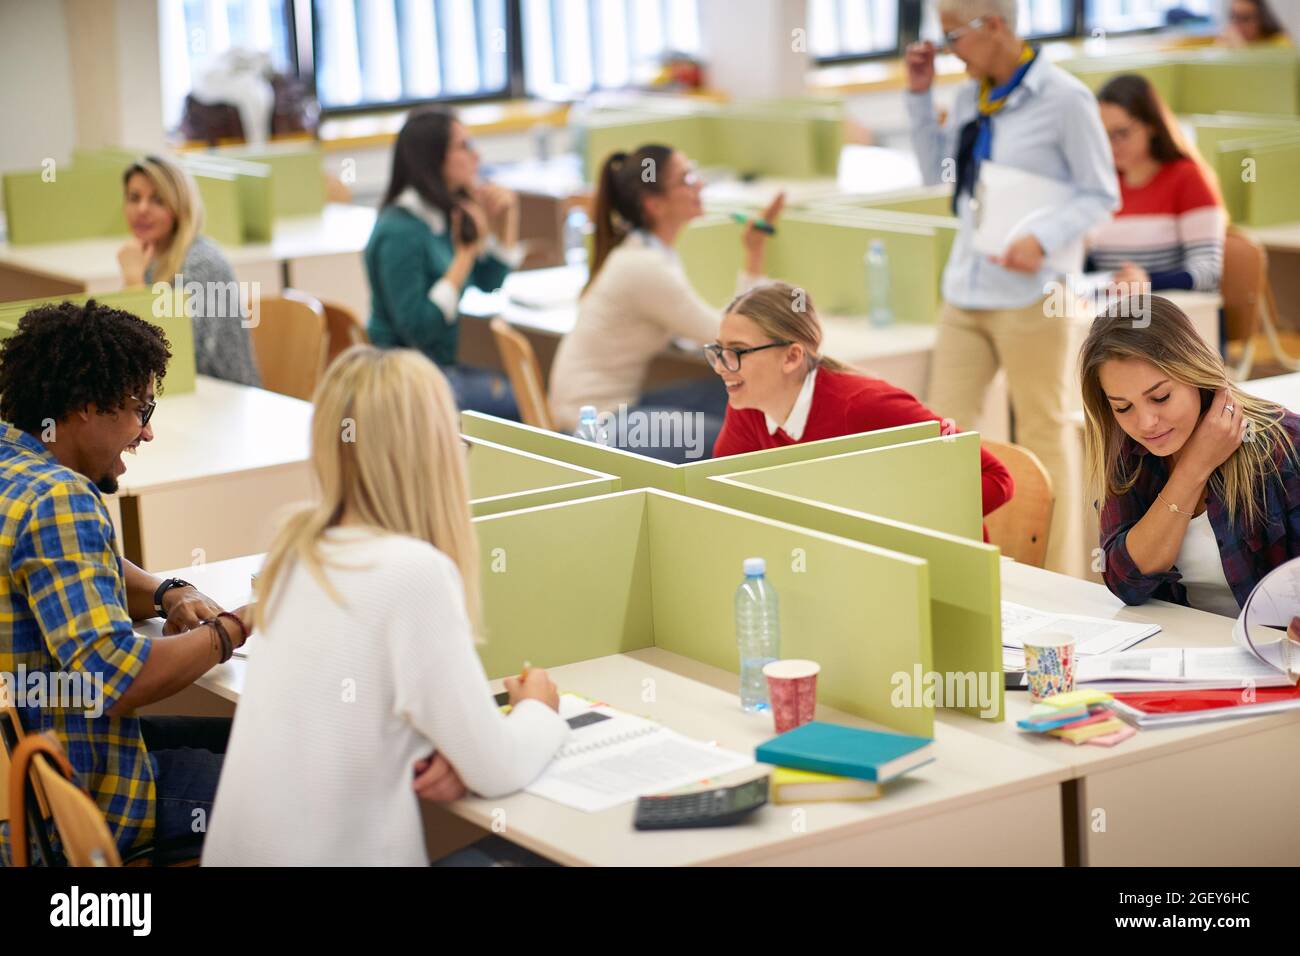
[0,203,377,321]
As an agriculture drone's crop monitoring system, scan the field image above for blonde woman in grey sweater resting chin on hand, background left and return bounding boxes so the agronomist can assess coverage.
[117,156,261,385]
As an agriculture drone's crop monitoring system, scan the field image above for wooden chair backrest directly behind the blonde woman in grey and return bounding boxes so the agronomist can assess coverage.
[252,289,328,401]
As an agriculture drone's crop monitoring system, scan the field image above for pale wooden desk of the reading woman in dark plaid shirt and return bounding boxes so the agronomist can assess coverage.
[940,561,1300,866]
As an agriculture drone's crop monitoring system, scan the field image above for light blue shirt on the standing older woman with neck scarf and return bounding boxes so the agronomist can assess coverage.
[905,55,1119,308]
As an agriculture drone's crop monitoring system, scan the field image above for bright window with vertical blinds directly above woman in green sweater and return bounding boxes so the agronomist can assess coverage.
[312,0,510,109]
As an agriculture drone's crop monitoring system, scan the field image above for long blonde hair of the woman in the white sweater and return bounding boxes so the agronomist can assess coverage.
[255,345,480,631]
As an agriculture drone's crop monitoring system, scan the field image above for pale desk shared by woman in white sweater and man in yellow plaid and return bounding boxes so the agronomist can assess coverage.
[142,546,1069,866]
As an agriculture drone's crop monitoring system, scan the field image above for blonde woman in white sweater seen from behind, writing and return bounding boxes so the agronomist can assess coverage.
[203,346,568,865]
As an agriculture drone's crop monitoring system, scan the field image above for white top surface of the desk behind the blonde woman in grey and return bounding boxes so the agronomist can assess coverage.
[0,203,377,282]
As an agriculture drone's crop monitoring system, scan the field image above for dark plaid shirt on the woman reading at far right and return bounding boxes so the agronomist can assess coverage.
[1100,411,1300,606]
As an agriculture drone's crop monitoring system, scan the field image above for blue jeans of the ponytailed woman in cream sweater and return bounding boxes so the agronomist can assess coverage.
[606,376,727,464]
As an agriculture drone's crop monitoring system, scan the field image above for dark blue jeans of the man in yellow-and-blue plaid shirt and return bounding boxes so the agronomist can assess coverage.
[140,717,230,849]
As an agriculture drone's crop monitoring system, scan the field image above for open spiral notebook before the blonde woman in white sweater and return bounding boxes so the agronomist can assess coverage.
[525,695,754,813]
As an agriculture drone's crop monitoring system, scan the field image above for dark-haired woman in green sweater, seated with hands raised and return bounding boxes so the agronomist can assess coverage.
[365,108,524,419]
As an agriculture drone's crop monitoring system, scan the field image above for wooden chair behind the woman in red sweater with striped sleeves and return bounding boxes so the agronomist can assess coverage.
[1219,226,1300,381]
